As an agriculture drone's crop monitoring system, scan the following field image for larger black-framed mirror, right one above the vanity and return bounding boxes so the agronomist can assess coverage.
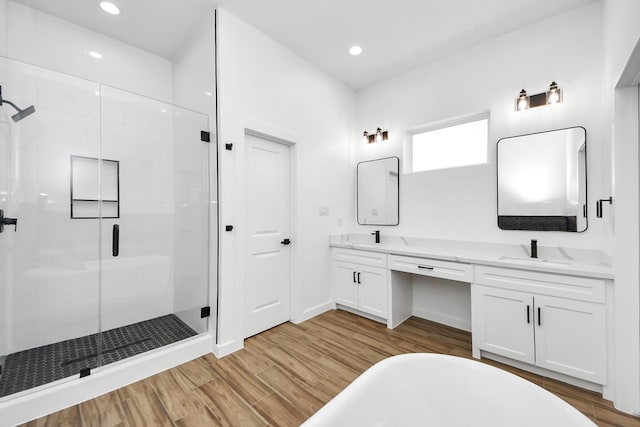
[497,127,587,232]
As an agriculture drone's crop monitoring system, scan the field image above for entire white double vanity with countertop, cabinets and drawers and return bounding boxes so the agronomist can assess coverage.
[330,234,613,398]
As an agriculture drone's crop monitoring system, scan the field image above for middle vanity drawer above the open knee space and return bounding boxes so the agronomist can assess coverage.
[389,255,473,283]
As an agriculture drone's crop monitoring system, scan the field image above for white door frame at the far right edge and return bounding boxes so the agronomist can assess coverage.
[605,42,640,415]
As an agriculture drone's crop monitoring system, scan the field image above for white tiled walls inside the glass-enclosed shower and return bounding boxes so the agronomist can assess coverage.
[0,0,216,354]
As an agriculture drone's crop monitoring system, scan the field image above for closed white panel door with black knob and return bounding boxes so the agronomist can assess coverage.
[245,134,290,337]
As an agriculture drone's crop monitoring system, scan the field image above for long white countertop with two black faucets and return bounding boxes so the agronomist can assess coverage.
[329,234,614,279]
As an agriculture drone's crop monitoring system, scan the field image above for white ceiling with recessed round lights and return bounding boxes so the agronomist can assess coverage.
[16,0,598,90]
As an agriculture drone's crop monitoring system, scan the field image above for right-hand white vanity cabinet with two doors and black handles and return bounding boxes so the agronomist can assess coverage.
[471,266,607,384]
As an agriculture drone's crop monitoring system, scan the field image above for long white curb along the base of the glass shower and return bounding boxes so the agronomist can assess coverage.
[0,334,212,426]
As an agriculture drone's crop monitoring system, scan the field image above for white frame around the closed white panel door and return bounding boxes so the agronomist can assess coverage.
[238,127,298,339]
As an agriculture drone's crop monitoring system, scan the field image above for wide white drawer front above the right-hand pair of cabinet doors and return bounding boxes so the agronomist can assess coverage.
[475,265,605,303]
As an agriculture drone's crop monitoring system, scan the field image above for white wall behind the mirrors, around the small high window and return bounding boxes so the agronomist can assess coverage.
[354,3,608,249]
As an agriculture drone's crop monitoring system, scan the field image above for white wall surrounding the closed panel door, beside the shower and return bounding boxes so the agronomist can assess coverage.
[218,9,355,354]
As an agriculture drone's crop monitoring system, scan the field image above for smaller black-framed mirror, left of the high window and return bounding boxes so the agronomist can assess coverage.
[357,157,400,225]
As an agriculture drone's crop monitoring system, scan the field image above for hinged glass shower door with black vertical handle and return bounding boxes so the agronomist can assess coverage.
[101,86,209,363]
